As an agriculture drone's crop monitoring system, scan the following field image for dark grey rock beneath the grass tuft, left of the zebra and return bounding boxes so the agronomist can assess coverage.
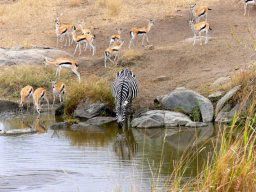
[74,102,109,119]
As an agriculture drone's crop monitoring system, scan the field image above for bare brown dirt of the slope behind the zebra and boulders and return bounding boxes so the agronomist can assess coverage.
[0,1,256,106]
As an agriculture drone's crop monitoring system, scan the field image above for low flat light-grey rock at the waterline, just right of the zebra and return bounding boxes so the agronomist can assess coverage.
[131,110,192,128]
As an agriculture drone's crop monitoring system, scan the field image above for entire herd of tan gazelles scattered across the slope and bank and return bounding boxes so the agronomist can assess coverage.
[20,0,251,114]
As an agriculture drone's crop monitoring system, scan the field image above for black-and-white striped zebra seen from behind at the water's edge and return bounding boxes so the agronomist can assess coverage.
[112,68,138,128]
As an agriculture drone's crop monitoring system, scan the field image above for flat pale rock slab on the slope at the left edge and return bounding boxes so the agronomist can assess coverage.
[0,46,71,66]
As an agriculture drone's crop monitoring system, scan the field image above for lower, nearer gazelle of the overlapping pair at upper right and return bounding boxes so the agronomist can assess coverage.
[189,20,212,46]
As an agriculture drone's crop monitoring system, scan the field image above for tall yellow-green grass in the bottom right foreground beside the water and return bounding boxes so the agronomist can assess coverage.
[166,111,256,192]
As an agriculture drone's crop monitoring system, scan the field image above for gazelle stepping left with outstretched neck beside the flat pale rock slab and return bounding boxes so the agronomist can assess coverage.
[43,57,81,82]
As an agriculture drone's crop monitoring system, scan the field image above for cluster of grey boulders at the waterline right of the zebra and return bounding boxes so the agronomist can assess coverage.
[131,86,245,128]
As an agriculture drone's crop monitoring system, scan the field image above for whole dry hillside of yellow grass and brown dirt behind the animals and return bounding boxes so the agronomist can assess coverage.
[0,0,256,105]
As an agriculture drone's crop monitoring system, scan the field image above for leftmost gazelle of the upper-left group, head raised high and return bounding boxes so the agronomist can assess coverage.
[55,16,74,47]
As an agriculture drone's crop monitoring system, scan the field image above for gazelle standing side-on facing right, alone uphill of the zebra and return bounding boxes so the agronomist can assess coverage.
[129,20,154,49]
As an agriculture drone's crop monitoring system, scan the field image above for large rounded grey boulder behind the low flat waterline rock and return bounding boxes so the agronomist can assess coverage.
[157,87,214,122]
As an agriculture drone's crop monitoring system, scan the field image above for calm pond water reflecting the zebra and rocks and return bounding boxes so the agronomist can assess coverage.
[0,114,215,192]
